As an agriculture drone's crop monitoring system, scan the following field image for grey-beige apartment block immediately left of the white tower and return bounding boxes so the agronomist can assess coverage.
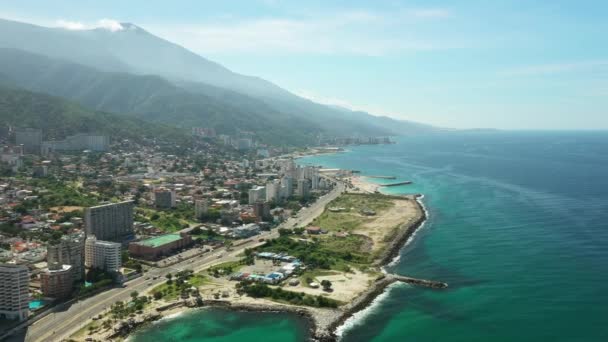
[46,234,85,280]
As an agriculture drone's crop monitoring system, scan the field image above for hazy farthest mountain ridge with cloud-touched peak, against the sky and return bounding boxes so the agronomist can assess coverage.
[0,20,434,139]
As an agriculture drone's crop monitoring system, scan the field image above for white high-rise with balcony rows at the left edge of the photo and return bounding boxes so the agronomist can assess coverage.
[0,264,30,321]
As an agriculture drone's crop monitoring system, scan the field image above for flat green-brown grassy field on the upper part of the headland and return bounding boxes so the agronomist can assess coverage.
[312,194,394,232]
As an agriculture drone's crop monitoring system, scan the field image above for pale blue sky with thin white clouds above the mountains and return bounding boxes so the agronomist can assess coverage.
[0,0,608,130]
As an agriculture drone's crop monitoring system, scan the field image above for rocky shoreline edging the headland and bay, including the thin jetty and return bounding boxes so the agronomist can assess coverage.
[109,171,448,342]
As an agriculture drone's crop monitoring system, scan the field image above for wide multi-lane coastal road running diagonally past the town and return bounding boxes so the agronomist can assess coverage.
[25,182,345,342]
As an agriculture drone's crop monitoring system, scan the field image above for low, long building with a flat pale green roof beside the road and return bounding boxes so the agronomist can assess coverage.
[129,233,192,260]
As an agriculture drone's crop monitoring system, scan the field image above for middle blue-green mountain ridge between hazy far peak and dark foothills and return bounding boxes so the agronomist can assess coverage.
[0,49,321,145]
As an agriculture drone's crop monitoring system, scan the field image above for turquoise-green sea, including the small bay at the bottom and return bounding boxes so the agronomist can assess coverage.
[133,132,608,342]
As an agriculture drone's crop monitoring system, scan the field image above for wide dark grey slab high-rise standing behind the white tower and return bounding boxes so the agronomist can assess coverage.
[84,201,133,242]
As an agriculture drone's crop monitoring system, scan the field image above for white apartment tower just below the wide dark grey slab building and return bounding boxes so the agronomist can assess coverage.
[84,236,122,273]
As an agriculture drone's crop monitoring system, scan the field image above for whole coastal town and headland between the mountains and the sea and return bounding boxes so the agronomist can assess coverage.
[0,128,443,341]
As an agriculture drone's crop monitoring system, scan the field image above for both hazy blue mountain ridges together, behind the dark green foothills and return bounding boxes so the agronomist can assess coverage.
[0,20,435,145]
